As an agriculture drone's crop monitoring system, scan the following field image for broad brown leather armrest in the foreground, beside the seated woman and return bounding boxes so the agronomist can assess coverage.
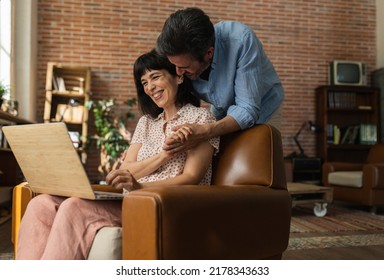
[122,185,291,260]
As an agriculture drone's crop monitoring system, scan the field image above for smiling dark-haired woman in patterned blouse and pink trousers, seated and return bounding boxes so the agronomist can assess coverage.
[16,51,219,259]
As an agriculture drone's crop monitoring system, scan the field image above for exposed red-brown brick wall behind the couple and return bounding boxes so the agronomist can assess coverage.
[37,0,376,183]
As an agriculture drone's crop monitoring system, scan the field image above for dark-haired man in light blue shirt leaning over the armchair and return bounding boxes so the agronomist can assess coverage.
[157,8,284,152]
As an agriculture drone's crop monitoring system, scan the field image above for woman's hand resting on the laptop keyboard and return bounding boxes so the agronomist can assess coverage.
[106,169,141,191]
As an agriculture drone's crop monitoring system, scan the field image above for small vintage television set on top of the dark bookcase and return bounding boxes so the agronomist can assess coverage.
[328,60,367,86]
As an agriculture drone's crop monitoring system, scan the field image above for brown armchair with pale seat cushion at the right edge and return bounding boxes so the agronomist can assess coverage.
[323,144,384,213]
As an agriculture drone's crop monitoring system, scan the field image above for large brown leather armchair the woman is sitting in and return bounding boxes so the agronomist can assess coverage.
[13,125,291,260]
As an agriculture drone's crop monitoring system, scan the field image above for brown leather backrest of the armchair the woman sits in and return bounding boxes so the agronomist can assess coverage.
[212,124,287,189]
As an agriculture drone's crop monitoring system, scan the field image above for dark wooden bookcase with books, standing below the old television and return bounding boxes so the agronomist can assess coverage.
[316,86,381,162]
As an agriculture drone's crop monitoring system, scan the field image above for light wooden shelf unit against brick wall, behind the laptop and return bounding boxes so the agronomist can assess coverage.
[44,62,91,162]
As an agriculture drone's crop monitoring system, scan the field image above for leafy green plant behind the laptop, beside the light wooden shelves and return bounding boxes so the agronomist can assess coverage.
[85,98,136,177]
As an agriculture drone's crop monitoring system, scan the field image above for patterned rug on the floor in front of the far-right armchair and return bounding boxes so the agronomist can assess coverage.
[288,204,384,250]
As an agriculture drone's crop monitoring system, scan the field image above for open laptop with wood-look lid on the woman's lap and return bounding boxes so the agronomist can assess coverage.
[3,122,123,200]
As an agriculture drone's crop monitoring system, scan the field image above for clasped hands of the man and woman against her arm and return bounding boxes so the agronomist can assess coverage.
[163,124,209,154]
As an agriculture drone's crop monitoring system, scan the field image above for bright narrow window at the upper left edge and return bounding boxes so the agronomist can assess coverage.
[0,0,11,99]
